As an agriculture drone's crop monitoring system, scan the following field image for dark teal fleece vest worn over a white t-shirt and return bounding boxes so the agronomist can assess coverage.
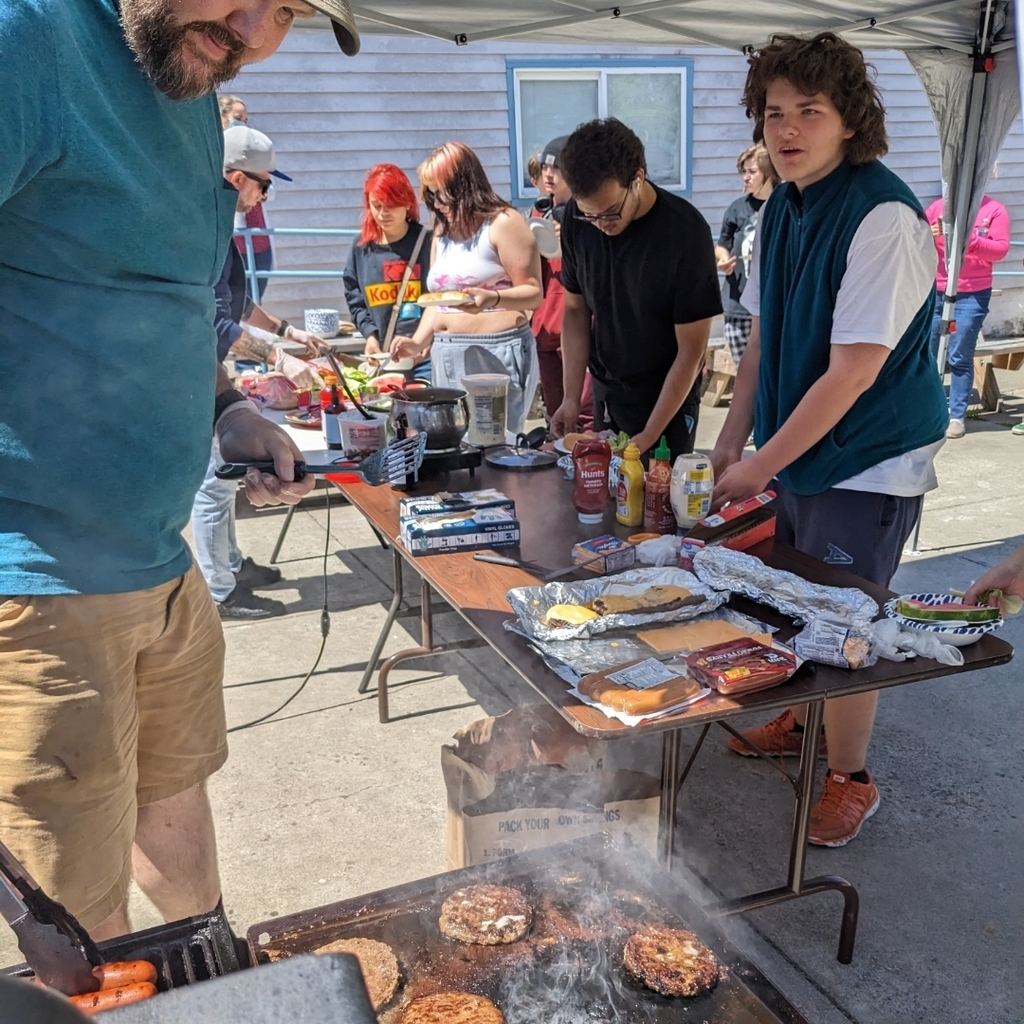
[754,161,949,495]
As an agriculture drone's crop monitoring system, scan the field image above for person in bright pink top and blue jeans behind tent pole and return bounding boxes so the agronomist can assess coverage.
[925,196,1010,437]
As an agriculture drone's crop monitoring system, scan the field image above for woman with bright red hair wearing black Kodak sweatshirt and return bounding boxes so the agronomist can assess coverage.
[344,164,430,364]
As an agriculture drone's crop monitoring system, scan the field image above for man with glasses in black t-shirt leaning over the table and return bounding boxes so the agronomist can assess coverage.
[551,118,722,459]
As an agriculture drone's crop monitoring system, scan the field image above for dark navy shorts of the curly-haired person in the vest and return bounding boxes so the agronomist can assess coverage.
[769,480,925,587]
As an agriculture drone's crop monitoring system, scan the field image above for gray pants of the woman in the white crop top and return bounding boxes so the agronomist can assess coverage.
[430,324,540,433]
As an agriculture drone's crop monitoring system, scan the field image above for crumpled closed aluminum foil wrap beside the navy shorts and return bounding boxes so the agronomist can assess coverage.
[693,547,879,623]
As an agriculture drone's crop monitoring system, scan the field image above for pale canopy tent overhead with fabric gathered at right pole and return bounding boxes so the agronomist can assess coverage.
[352,0,1024,550]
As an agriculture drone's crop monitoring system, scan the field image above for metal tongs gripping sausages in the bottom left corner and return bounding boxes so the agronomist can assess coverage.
[0,843,103,995]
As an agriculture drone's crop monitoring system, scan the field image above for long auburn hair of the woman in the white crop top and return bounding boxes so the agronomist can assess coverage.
[416,142,511,238]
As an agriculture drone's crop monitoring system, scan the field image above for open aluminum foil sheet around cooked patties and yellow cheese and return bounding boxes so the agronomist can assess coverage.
[505,567,729,640]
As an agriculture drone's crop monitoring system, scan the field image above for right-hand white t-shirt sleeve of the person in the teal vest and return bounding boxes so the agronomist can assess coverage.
[831,203,937,349]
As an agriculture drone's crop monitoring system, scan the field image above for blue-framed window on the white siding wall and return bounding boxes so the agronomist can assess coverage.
[506,57,693,201]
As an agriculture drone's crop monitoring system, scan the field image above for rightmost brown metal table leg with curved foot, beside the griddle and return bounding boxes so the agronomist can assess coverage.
[705,700,860,964]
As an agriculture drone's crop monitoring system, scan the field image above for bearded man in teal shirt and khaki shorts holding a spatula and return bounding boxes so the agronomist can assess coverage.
[0,0,358,939]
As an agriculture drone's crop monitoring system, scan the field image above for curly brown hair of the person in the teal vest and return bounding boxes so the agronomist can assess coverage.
[741,32,889,165]
